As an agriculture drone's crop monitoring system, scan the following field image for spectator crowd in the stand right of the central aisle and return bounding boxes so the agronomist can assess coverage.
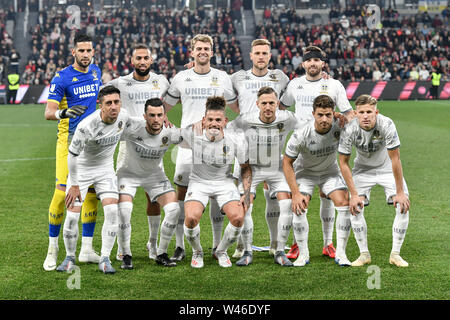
[255,6,450,81]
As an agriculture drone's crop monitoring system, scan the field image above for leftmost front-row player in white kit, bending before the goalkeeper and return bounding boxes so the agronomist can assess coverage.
[56,86,128,273]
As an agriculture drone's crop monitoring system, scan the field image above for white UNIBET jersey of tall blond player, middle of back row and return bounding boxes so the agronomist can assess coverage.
[164,68,236,128]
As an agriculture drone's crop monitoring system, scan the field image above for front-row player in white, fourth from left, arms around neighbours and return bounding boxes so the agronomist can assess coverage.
[228,87,299,266]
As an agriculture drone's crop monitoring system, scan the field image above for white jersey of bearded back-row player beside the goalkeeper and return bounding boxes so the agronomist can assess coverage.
[105,72,169,117]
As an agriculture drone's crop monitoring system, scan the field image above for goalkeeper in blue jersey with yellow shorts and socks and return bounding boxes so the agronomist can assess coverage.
[43,34,102,271]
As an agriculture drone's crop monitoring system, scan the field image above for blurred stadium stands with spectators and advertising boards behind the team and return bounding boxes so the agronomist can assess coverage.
[0,0,450,104]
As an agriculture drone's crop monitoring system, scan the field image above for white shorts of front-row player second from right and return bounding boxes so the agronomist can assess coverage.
[297,173,347,198]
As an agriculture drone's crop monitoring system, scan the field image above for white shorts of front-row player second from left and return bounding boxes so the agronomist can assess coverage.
[117,170,175,202]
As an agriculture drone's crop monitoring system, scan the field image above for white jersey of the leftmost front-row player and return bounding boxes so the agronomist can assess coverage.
[69,109,129,173]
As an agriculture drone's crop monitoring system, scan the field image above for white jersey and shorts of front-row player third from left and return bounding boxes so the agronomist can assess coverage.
[182,129,248,208]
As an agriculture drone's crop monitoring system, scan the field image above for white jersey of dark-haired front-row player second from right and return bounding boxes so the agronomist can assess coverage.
[285,120,341,177]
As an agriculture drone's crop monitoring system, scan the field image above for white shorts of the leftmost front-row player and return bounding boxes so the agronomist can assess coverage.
[66,170,119,206]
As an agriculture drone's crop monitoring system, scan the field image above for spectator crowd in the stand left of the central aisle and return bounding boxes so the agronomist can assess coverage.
[22,6,244,84]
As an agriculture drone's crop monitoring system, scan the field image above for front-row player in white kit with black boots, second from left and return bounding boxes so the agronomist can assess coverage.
[117,98,184,269]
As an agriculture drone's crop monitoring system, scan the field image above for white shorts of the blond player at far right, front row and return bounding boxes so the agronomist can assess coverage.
[353,172,409,205]
